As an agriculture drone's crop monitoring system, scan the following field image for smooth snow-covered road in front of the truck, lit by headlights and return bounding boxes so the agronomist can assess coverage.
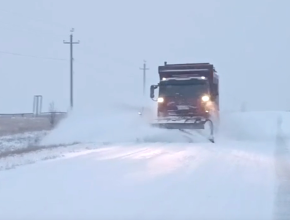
[0,140,275,219]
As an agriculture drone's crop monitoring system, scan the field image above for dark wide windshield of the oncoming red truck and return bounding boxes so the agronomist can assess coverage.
[159,84,208,97]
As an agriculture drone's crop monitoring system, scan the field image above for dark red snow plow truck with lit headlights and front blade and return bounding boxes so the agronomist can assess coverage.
[150,62,219,143]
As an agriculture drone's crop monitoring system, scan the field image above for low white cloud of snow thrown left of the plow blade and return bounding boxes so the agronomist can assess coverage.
[41,111,208,145]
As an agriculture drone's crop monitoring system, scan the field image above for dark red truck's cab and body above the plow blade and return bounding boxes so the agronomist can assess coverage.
[150,63,219,118]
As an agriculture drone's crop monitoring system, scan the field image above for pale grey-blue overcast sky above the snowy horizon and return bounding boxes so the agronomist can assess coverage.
[0,0,290,113]
